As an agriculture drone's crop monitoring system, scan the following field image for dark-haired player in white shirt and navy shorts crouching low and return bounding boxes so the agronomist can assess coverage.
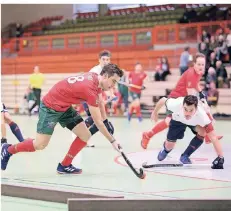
[154,95,224,169]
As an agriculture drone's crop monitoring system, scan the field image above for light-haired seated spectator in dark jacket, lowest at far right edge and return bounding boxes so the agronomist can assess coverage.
[216,60,228,88]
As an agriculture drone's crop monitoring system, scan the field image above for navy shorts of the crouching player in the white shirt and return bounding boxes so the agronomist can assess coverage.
[167,119,197,142]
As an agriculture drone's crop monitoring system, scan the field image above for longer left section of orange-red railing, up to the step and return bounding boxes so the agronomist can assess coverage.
[4,28,153,54]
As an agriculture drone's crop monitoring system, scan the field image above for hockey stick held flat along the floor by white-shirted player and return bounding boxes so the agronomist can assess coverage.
[142,163,211,169]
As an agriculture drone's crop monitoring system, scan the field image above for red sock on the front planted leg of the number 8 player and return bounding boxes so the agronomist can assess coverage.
[61,137,87,166]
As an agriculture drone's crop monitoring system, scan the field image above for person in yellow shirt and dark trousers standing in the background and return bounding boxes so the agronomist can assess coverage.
[29,66,44,115]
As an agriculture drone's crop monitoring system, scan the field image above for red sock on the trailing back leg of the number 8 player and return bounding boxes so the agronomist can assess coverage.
[8,139,35,154]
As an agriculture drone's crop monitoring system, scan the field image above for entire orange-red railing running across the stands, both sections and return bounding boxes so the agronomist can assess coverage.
[3,21,231,55]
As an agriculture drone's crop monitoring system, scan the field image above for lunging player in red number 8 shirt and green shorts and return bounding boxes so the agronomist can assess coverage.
[1,64,123,174]
